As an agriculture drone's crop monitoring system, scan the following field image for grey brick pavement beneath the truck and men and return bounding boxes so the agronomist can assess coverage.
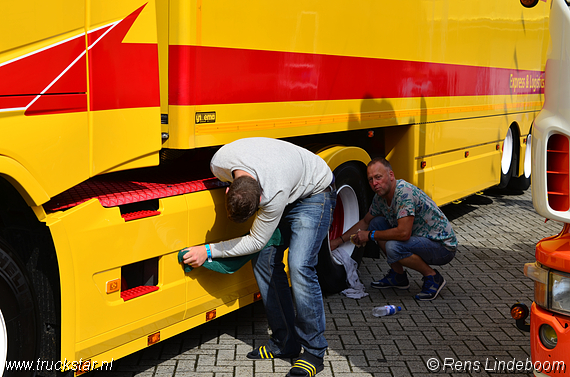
[90,190,561,377]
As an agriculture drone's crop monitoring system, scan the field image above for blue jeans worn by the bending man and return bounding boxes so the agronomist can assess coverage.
[252,191,336,358]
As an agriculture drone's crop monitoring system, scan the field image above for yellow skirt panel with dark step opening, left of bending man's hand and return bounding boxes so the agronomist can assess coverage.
[48,196,188,360]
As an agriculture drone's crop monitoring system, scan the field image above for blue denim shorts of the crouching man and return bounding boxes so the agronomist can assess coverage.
[368,216,455,266]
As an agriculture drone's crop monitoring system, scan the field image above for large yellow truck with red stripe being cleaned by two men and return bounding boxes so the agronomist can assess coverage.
[0,0,550,375]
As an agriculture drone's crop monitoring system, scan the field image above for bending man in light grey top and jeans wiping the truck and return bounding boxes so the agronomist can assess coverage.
[184,138,336,377]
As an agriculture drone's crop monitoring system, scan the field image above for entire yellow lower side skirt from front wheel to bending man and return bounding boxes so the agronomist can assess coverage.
[46,189,253,360]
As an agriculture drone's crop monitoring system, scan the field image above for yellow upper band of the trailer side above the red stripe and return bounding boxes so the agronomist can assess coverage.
[170,0,549,69]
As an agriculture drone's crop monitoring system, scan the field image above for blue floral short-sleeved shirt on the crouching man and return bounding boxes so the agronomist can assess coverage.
[370,179,457,251]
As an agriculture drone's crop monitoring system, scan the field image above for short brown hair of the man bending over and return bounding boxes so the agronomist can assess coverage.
[226,176,261,223]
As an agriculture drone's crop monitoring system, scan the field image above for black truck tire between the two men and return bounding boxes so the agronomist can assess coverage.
[317,161,372,293]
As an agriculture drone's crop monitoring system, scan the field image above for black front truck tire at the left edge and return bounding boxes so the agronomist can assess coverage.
[0,241,39,377]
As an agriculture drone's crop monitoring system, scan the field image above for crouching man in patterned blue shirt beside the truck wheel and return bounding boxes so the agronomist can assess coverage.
[331,158,457,301]
